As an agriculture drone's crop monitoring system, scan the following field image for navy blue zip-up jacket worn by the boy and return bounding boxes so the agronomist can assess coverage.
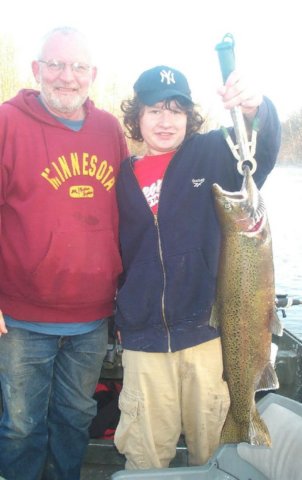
[116,99,280,352]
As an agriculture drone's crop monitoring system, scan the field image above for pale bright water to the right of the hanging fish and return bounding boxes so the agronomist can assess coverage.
[261,167,302,340]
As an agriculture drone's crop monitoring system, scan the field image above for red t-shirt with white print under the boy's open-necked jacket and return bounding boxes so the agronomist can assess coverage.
[134,150,175,214]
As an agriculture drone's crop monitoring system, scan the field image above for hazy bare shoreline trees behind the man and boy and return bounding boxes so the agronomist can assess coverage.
[0,35,302,166]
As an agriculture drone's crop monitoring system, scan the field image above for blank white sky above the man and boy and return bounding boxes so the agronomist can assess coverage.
[0,0,302,118]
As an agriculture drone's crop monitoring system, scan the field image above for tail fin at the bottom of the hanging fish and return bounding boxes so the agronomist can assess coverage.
[220,407,272,447]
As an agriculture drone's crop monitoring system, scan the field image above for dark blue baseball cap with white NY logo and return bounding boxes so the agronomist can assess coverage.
[133,65,193,106]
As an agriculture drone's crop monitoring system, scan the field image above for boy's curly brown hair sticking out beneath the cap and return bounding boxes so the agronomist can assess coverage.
[121,96,204,142]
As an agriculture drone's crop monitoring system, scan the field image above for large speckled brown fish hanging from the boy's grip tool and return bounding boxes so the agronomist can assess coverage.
[211,167,282,446]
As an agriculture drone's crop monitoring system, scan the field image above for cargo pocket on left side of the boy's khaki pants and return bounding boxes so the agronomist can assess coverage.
[114,388,143,462]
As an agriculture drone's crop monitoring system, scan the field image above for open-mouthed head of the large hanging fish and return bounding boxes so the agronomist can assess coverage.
[212,167,267,236]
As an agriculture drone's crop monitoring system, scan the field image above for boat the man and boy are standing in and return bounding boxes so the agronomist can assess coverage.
[81,295,302,480]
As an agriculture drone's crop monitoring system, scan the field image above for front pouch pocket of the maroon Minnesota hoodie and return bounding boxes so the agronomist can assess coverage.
[29,230,122,305]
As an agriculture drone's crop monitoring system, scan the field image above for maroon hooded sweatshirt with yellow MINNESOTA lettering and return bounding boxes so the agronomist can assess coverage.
[0,90,127,323]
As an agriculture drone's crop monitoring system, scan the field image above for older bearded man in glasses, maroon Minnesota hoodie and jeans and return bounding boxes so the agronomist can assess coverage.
[0,28,127,480]
